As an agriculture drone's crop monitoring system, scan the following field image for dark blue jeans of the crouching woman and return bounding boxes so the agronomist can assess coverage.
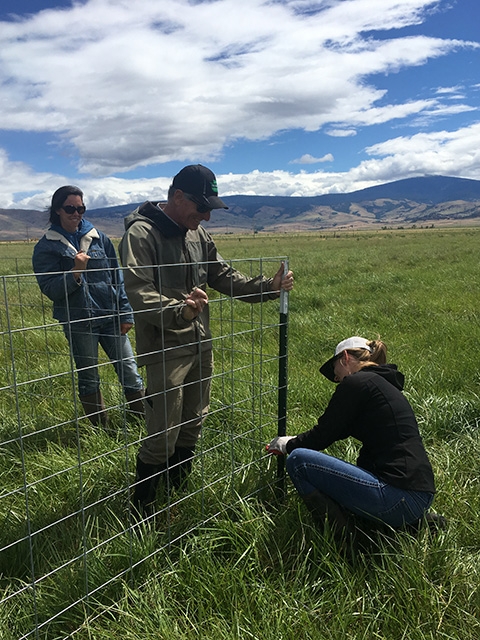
[286,449,433,528]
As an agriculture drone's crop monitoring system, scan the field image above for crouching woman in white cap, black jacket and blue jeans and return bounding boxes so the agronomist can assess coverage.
[267,336,435,537]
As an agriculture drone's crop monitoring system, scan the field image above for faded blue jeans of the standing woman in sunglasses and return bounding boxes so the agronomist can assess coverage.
[63,318,143,396]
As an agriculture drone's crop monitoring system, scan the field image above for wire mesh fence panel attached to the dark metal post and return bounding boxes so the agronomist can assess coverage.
[0,257,287,638]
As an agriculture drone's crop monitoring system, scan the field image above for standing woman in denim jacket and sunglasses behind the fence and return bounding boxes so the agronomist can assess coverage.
[33,186,144,426]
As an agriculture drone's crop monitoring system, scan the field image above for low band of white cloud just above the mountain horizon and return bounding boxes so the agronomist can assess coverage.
[0,122,480,209]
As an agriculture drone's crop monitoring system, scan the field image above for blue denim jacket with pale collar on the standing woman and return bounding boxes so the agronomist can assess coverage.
[32,227,133,323]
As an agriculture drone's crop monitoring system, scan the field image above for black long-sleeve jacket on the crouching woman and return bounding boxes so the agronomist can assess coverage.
[287,364,435,492]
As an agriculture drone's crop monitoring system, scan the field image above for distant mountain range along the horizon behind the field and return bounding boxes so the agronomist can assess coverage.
[0,176,480,240]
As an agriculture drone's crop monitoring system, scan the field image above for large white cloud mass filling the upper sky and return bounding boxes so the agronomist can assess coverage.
[0,0,473,177]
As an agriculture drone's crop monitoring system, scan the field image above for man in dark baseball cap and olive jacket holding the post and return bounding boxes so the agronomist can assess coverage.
[119,164,293,518]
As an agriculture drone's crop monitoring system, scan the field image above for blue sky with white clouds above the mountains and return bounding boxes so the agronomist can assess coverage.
[0,0,480,209]
